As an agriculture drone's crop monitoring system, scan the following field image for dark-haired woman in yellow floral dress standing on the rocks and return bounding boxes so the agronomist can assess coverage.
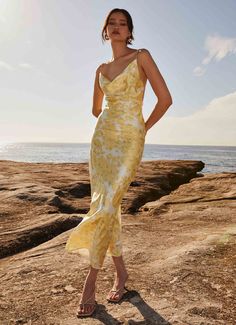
[66,8,172,317]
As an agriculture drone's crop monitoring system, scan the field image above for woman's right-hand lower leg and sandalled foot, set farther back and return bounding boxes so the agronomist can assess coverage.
[108,255,128,300]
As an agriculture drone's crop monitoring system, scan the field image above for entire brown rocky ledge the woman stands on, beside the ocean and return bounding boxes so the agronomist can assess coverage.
[0,160,236,325]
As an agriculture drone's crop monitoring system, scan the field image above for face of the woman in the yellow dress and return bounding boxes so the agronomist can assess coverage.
[106,12,130,42]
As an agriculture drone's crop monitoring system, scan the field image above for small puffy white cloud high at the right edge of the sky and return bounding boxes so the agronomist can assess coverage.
[193,34,236,77]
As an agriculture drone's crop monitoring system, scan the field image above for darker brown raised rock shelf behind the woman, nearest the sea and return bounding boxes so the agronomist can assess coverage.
[0,160,204,257]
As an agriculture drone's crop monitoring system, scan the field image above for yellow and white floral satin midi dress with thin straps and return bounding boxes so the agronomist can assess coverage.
[65,50,146,269]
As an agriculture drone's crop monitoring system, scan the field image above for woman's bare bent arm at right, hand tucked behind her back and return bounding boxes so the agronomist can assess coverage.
[140,49,172,132]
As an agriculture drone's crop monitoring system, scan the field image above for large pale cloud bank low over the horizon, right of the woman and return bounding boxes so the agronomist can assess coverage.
[146,91,236,146]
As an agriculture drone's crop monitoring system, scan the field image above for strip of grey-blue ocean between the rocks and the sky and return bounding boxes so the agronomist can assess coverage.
[0,142,236,173]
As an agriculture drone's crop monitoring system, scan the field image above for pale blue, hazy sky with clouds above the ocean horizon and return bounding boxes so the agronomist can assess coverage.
[0,0,236,146]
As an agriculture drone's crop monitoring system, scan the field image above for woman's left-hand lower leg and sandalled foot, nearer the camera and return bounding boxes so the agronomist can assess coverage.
[78,266,99,314]
